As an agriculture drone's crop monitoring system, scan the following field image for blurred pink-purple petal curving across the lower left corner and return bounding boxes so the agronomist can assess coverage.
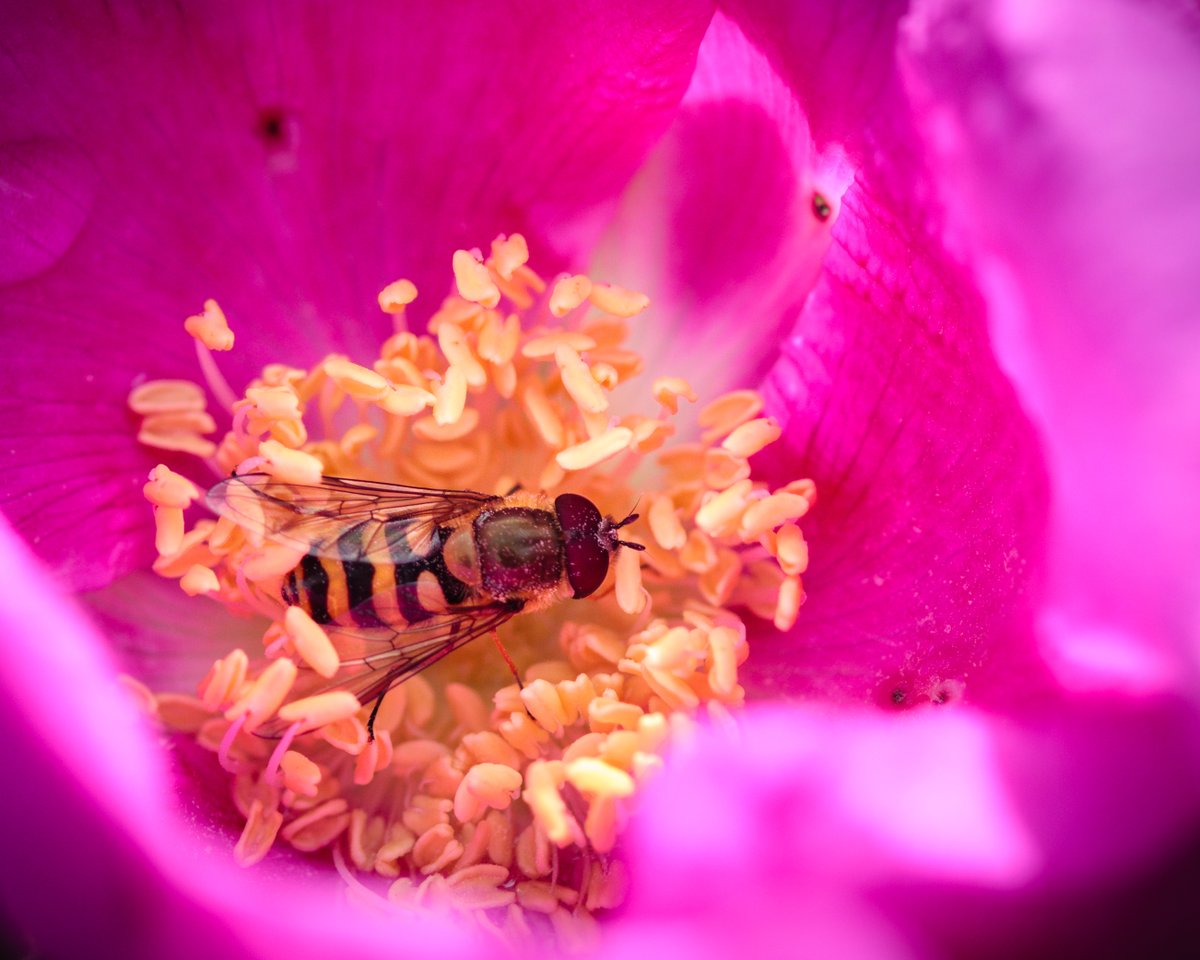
[0,520,494,958]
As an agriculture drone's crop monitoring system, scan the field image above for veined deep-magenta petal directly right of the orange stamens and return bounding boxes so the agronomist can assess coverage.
[746,104,1045,706]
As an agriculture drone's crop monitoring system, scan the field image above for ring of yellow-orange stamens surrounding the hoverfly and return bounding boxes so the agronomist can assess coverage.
[130,235,815,946]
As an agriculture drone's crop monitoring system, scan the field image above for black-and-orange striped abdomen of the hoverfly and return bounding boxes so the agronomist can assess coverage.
[282,521,472,629]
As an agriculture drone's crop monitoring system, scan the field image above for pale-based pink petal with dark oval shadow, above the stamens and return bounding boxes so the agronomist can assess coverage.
[592,14,844,398]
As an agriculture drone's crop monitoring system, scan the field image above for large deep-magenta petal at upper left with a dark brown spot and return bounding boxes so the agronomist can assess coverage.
[0,0,710,587]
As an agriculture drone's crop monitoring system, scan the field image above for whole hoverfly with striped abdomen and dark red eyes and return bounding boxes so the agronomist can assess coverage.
[208,473,644,739]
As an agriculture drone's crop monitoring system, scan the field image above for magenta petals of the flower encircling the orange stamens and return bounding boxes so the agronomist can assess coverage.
[0,2,1198,955]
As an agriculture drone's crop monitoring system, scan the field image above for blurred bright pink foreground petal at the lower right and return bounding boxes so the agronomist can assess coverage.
[618,700,1200,956]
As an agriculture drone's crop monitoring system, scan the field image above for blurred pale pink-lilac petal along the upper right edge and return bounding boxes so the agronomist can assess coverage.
[905,0,1200,688]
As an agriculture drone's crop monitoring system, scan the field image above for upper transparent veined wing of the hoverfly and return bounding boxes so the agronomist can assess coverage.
[208,473,500,563]
